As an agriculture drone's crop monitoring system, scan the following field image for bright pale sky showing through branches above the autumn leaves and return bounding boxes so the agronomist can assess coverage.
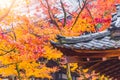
[0,0,78,23]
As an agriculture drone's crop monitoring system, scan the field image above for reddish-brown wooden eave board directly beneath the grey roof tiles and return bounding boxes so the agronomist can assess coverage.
[60,48,120,58]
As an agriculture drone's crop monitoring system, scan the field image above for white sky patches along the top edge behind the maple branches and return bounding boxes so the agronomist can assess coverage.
[0,0,78,17]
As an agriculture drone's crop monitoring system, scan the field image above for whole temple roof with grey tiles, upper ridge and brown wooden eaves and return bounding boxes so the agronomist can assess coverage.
[51,4,120,80]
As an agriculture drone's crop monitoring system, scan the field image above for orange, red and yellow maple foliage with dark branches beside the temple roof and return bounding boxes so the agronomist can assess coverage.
[0,0,120,80]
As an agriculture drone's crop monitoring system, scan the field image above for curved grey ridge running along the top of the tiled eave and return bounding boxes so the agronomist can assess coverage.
[57,30,111,44]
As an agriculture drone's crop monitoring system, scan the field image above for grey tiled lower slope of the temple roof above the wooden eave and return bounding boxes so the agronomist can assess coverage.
[52,35,120,50]
